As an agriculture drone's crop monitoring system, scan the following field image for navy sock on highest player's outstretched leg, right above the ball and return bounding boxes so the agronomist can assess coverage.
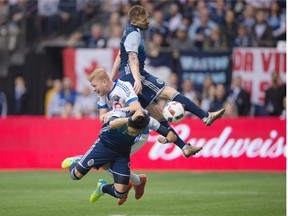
[172,94,208,119]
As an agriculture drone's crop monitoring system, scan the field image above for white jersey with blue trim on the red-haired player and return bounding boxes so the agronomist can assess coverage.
[97,79,138,110]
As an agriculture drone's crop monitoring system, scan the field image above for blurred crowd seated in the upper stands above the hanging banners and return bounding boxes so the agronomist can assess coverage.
[0,0,286,50]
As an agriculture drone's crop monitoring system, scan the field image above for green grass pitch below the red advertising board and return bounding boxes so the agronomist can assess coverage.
[0,171,286,216]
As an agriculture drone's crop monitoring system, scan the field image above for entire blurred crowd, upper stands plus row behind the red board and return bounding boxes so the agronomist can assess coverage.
[0,0,286,117]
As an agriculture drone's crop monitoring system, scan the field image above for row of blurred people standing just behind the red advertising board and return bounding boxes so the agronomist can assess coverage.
[0,67,286,118]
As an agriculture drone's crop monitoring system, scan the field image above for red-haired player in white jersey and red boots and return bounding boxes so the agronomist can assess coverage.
[64,68,202,205]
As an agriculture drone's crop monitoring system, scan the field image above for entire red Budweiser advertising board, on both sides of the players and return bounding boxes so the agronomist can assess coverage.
[0,117,286,171]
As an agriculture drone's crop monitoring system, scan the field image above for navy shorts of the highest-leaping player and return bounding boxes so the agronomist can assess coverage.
[120,71,166,109]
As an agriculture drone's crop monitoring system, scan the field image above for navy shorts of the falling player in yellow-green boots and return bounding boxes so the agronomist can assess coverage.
[78,139,130,184]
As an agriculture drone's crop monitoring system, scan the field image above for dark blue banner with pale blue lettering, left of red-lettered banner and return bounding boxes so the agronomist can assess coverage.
[179,51,232,88]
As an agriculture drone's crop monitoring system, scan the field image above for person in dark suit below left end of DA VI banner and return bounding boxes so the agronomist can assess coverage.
[228,76,251,116]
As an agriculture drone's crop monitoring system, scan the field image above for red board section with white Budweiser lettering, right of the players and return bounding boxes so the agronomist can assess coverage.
[131,118,286,170]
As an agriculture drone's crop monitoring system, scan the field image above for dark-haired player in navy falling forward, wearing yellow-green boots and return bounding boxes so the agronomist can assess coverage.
[62,109,177,204]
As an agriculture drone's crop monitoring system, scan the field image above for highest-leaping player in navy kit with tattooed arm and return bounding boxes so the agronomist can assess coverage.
[112,5,225,126]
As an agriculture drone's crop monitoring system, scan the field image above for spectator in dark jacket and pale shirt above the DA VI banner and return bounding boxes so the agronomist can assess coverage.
[251,10,274,47]
